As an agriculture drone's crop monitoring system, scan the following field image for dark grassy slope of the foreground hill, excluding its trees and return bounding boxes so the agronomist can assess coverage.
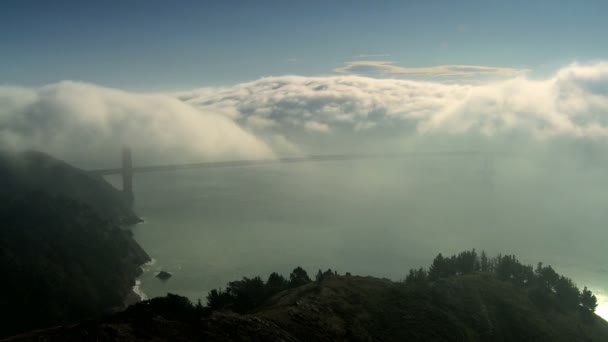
[11,273,608,342]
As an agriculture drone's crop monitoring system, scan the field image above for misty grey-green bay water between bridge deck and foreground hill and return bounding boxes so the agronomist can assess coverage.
[124,155,608,317]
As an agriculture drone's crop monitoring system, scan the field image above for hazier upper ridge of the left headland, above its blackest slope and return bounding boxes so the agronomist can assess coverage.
[0,151,140,224]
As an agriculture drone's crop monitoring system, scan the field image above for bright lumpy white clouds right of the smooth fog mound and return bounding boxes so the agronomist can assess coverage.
[182,63,608,145]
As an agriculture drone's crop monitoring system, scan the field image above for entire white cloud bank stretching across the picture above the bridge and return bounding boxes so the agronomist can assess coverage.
[0,62,608,164]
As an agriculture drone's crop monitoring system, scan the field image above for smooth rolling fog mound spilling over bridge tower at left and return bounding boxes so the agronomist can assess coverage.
[0,82,272,165]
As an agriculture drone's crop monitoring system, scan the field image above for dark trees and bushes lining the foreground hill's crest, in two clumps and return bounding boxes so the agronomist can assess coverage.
[127,249,597,320]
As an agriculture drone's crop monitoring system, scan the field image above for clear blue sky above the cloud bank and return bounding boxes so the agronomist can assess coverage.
[0,0,608,90]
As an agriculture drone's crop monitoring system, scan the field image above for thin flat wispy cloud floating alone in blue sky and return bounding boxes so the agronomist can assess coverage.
[334,61,528,77]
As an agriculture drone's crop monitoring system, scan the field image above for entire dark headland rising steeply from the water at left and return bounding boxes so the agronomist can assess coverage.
[0,152,149,337]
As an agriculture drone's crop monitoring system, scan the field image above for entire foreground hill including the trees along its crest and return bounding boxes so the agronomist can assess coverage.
[10,251,608,341]
